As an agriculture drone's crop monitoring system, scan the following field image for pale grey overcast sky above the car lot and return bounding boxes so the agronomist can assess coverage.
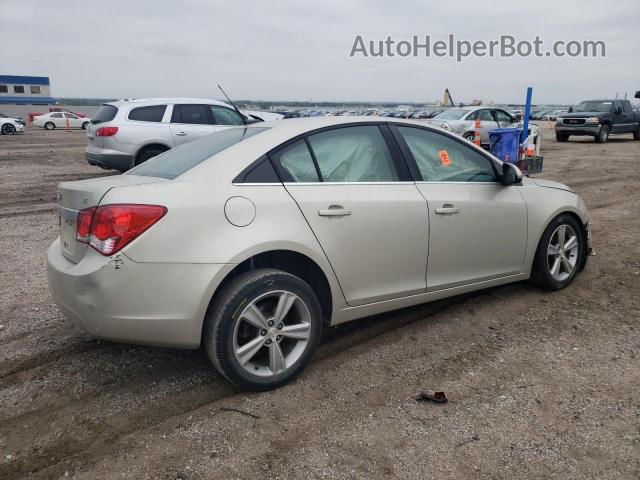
[0,0,640,103]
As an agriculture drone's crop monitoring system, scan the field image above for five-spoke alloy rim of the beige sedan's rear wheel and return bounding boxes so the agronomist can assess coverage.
[233,290,311,377]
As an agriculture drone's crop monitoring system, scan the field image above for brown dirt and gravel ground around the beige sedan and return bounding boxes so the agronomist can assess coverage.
[0,125,640,480]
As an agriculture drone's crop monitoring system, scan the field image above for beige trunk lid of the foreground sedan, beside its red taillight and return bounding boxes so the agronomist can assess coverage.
[57,175,167,263]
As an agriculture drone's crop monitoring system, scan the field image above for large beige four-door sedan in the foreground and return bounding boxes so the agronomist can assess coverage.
[48,117,590,390]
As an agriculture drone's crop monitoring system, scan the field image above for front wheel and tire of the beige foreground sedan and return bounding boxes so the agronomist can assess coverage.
[531,214,586,291]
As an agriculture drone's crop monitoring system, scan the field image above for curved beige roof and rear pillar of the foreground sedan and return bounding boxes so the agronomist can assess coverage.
[179,116,496,181]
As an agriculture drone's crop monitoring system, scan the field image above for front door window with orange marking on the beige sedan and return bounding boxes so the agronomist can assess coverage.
[397,127,496,182]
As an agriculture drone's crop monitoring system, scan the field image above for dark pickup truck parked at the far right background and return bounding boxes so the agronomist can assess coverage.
[556,100,640,143]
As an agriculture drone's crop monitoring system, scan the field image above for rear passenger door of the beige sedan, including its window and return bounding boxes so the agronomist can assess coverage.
[271,124,428,306]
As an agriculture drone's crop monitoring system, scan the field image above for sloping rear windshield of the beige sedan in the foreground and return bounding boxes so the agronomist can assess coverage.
[127,127,268,180]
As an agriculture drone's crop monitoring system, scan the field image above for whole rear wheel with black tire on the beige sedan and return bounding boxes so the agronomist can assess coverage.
[202,269,323,391]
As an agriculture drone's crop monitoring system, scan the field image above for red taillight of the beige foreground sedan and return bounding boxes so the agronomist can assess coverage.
[76,204,167,256]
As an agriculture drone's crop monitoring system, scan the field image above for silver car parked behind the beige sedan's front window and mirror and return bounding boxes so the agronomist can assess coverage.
[428,107,521,146]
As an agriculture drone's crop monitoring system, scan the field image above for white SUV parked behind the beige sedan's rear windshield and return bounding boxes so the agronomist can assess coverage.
[85,98,257,172]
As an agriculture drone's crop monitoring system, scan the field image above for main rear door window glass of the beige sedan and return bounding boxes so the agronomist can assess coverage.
[309,126,399,182]
